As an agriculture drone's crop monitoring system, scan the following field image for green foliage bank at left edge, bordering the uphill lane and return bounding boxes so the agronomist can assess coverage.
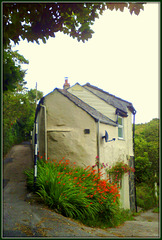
[3,89,43,154]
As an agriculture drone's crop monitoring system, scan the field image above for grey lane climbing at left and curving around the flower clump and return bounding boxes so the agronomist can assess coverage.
[2,143,160,238]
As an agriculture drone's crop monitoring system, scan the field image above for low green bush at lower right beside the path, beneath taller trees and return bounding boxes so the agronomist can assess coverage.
[136,183,157,210]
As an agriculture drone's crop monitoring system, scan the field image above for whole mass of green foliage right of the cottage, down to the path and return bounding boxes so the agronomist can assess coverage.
[135,118,159,210]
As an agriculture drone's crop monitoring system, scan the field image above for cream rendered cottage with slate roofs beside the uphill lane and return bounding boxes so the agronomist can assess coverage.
[36,80,136,210]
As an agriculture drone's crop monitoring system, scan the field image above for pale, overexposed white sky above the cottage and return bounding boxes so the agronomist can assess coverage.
[13,2,160,124]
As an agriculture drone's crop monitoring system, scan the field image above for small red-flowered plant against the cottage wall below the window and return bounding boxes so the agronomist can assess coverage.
[106,162,135,183]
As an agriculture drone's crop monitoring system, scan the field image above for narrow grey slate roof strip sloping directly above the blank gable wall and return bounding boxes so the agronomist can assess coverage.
[55,88,117,126]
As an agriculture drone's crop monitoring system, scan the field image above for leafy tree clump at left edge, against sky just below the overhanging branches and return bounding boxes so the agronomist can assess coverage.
[3,49,29,92]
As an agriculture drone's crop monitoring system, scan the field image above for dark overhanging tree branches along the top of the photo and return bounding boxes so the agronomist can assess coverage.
[3,2,144,48]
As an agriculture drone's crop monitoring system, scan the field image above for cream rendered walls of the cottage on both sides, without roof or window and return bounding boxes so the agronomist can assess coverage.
[38,90,133,209]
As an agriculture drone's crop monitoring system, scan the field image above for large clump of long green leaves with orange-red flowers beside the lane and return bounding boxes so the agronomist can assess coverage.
[26,159,120,226]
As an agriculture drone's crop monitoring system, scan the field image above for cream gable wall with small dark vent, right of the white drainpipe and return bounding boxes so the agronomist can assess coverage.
[44,90,97,167]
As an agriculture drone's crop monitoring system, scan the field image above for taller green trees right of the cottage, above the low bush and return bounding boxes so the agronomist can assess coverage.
[135,119,159,187]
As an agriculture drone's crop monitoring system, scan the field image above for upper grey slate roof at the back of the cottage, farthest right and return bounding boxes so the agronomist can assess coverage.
[82,83,136,115]
